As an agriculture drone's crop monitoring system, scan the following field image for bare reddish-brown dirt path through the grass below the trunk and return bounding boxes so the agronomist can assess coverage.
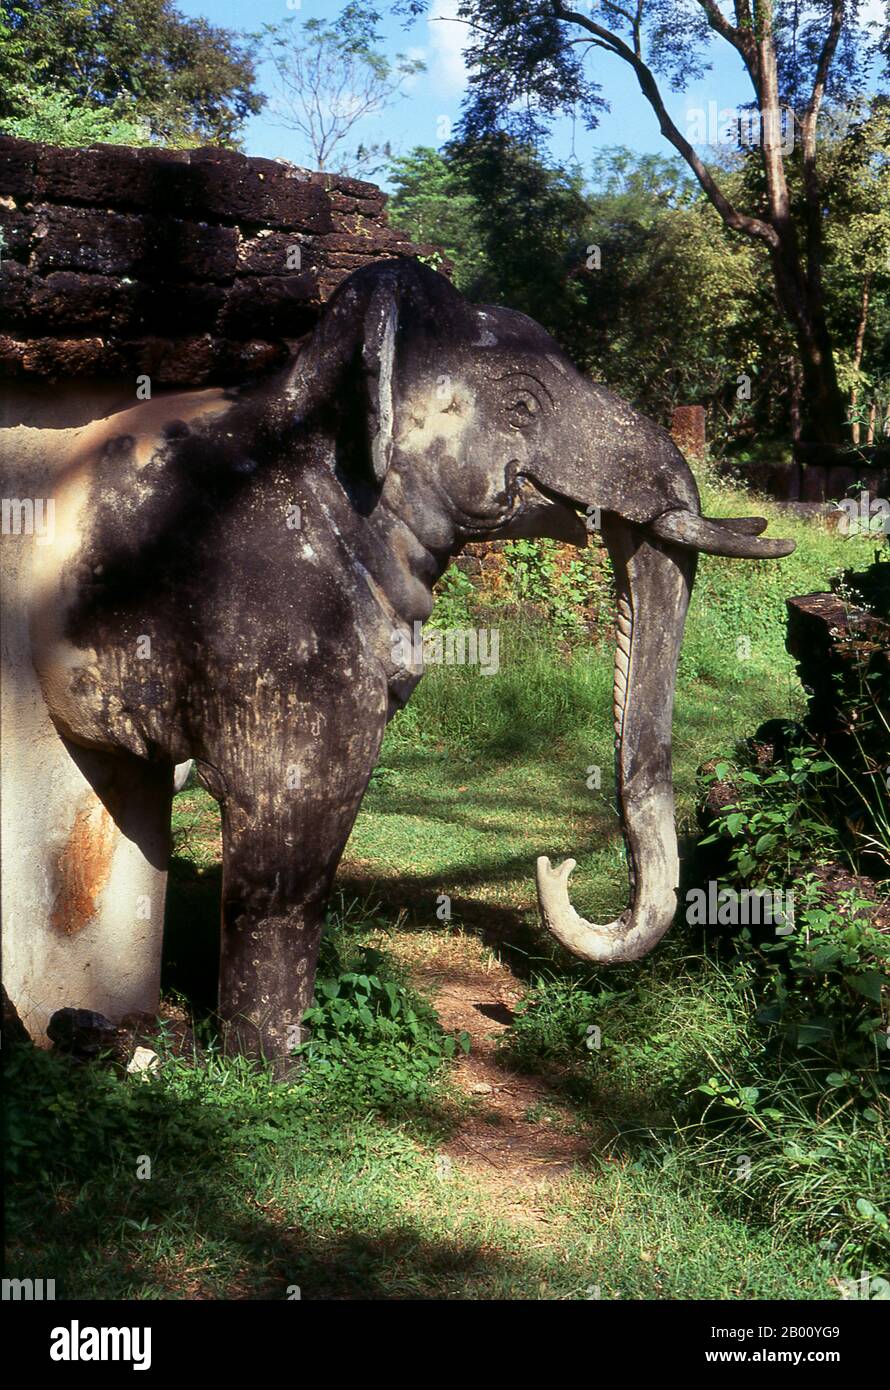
[387,933,590,1219]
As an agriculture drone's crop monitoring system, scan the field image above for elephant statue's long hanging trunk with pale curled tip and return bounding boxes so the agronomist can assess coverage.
[537,514,698,965]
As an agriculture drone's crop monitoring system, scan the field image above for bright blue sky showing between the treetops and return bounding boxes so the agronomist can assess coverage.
[178,0,883,182]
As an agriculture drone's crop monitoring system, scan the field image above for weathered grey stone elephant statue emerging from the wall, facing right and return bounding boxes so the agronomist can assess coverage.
[0,260,794,1058]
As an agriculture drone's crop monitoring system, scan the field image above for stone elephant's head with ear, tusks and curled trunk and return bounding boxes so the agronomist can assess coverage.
[289,261,794,962]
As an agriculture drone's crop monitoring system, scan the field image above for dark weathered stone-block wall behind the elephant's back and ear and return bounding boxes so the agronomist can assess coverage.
[0,138,444,386]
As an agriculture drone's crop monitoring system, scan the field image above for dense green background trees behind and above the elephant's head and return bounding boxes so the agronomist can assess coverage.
[389,126,890,452]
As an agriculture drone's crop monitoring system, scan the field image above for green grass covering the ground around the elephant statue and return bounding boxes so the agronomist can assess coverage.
[7,469,890,1300]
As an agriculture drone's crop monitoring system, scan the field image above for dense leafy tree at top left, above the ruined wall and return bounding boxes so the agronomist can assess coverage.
[0,0,264,145]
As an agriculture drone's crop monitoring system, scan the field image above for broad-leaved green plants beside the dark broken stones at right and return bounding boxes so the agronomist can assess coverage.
[701,728,890,1113]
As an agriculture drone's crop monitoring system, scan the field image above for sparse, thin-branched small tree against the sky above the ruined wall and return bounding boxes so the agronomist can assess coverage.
[263,3,424,174]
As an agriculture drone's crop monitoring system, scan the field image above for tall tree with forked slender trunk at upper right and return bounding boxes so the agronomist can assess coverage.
[396,0,886,442]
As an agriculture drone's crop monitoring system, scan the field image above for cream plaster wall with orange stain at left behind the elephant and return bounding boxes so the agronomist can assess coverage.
[0,388,168,1045]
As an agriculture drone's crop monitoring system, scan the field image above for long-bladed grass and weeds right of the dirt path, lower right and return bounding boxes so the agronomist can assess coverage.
[501,950,890,1276]
